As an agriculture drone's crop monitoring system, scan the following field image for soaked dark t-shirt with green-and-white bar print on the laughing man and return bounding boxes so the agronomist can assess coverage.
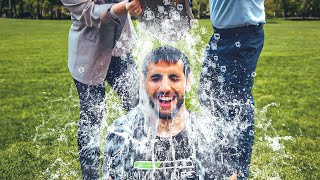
[103,107,235,180]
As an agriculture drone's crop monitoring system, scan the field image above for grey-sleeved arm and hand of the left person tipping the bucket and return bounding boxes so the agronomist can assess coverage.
[61,0,142,28]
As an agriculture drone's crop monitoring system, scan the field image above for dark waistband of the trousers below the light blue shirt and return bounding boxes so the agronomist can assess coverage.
[213,24,264,36]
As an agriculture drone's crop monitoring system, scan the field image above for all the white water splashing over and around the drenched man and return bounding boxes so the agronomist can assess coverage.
[33,4,293,179]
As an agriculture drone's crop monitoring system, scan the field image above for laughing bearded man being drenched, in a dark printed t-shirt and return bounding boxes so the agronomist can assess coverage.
[103,46,196,179]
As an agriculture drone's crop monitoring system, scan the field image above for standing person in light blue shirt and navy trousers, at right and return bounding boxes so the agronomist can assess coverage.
[198,0,265,179]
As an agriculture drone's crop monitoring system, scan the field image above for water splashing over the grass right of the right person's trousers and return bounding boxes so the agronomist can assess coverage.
[251,103,299,180]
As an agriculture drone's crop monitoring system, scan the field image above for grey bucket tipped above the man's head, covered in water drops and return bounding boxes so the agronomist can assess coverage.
[139,0,191,41]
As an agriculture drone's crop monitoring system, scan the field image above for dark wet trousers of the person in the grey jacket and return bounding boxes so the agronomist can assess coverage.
[74,54,139,180]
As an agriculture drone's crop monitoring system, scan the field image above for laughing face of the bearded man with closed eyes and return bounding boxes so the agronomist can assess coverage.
[146,60,186,119]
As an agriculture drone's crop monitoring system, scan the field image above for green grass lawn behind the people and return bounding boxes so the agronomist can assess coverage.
[0,18,320,180]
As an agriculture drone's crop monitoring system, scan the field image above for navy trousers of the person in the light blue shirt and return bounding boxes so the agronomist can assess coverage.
[198,25,264,179]
